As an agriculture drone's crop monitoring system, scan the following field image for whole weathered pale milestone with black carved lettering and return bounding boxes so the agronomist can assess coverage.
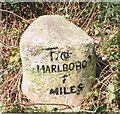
[20,15,96,110]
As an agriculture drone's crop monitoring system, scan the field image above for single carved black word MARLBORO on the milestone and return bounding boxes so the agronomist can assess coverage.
[37,58,89,74]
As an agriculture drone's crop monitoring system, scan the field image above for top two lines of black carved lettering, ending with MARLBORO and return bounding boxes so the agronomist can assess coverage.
[36,47,91,74]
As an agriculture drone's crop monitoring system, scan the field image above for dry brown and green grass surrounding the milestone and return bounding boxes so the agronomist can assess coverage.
[0,2,120,112]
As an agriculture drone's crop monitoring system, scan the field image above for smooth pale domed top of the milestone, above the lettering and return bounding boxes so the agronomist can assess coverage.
[21,15,93,47]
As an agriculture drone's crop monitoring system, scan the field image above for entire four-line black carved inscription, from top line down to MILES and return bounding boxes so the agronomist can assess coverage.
[36,47,91,95]
